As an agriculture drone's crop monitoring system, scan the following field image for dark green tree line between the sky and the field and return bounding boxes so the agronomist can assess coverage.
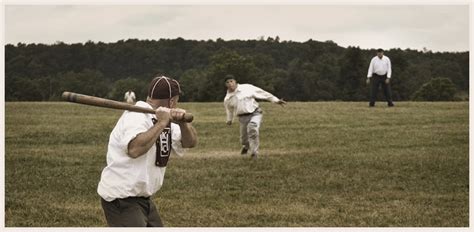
[5,37,469,102]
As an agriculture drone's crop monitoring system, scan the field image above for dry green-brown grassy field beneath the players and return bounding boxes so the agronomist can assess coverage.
[5,102,469,227]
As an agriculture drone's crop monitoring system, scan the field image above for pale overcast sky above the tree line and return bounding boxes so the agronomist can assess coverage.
[5,4,469,51]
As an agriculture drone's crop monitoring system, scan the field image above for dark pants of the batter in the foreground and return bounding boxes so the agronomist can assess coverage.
[101,197,163,227]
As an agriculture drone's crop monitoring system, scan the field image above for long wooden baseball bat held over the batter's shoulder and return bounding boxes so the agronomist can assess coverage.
[62,91,194,122]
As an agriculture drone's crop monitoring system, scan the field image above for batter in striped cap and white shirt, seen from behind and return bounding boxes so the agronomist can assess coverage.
[97,76,197,227]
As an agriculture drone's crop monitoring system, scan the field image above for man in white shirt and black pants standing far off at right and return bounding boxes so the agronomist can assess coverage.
[366,48,393,107]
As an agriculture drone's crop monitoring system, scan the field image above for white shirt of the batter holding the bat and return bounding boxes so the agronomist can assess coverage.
[97,101,184,201]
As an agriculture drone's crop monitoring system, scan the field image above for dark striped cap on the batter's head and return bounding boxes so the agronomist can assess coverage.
[148,76,181,99]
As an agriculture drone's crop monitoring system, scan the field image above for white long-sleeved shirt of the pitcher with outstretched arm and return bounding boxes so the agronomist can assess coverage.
[224,84,280,121]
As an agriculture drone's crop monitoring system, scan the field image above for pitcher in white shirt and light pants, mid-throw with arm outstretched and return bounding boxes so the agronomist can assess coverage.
[224,75,286,158]
